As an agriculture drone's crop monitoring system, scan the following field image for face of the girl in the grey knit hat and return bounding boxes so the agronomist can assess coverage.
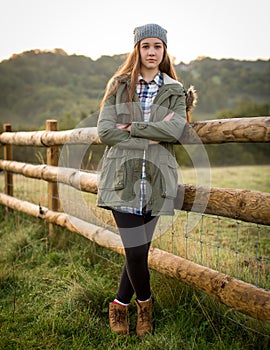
[140,38,164,71]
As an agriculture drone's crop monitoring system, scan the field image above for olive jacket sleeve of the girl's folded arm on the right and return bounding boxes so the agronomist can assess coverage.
[130,94,186,143]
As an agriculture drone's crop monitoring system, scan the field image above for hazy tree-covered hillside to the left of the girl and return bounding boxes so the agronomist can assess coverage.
[0,50,123,130]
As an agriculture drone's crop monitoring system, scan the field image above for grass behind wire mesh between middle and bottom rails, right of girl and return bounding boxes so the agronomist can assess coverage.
[153,212,270,289]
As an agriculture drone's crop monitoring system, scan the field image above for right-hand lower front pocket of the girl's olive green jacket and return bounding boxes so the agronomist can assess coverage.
[160,155,178,198]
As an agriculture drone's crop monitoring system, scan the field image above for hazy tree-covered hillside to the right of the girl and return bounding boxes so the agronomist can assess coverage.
[176,57,270,115]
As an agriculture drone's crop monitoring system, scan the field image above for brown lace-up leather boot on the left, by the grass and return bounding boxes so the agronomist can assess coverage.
[109,302,129,334]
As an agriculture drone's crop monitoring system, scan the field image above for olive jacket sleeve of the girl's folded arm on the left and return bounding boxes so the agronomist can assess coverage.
[97,96,149,150]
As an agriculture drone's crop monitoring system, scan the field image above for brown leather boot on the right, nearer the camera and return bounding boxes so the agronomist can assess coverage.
[135,297,154,338]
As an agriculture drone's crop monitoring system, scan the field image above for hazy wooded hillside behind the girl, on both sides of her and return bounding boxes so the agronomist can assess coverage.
[0,49,270,130]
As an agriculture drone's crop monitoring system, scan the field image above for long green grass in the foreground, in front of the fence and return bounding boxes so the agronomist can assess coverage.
[0,207,270,350]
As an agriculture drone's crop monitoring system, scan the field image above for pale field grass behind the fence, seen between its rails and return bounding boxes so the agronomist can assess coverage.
[0,165,270,289]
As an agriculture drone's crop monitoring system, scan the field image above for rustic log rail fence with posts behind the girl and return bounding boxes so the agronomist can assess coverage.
[0,117,270,323]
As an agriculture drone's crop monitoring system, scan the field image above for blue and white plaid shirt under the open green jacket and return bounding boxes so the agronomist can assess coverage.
[117,72,163,215]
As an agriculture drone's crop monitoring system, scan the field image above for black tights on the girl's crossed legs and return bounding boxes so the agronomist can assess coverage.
[112,210,158,304]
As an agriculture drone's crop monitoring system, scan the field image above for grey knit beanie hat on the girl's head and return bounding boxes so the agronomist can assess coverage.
[133,23,167,46]
